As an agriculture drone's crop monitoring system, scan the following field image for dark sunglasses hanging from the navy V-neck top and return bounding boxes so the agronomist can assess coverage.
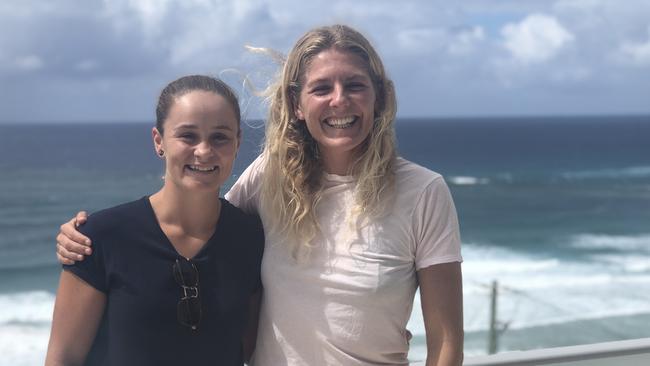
[172,258,201,330]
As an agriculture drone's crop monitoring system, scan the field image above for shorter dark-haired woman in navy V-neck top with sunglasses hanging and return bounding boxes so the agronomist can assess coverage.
[45,75,264,366]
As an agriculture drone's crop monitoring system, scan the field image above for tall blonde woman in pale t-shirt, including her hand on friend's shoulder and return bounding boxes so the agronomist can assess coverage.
[57,25,463,365]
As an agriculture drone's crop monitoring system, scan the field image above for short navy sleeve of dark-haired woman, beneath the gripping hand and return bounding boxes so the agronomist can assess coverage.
[63,216,108,293]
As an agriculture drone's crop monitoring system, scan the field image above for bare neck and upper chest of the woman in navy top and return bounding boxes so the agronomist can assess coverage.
[149,184,221,235]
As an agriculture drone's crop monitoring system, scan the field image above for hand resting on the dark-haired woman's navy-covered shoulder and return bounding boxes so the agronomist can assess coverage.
[56,211,92,264]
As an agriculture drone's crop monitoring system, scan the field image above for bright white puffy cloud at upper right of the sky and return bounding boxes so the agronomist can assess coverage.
[501,14,575,64]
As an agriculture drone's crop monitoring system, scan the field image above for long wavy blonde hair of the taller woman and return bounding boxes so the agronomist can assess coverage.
[261,25,397,256]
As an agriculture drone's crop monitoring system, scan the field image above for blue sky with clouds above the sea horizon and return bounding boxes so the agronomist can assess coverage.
[0,0,650,123]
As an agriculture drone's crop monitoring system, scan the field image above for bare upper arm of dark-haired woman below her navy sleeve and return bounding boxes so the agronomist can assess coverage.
[45,270,106,366]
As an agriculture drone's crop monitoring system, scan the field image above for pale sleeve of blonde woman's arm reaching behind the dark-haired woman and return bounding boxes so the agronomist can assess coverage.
[225,155,263,214]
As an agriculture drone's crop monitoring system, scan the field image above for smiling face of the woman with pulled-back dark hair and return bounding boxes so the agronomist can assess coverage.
[153,90,240,193]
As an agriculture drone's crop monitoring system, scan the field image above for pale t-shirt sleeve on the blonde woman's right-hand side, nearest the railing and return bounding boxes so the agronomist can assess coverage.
[413,176,463,270]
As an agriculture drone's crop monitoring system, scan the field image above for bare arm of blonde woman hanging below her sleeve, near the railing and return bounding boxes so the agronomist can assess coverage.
[417,262,464,366]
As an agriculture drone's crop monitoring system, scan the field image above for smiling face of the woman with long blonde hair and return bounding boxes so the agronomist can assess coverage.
[295,48,376,174]
